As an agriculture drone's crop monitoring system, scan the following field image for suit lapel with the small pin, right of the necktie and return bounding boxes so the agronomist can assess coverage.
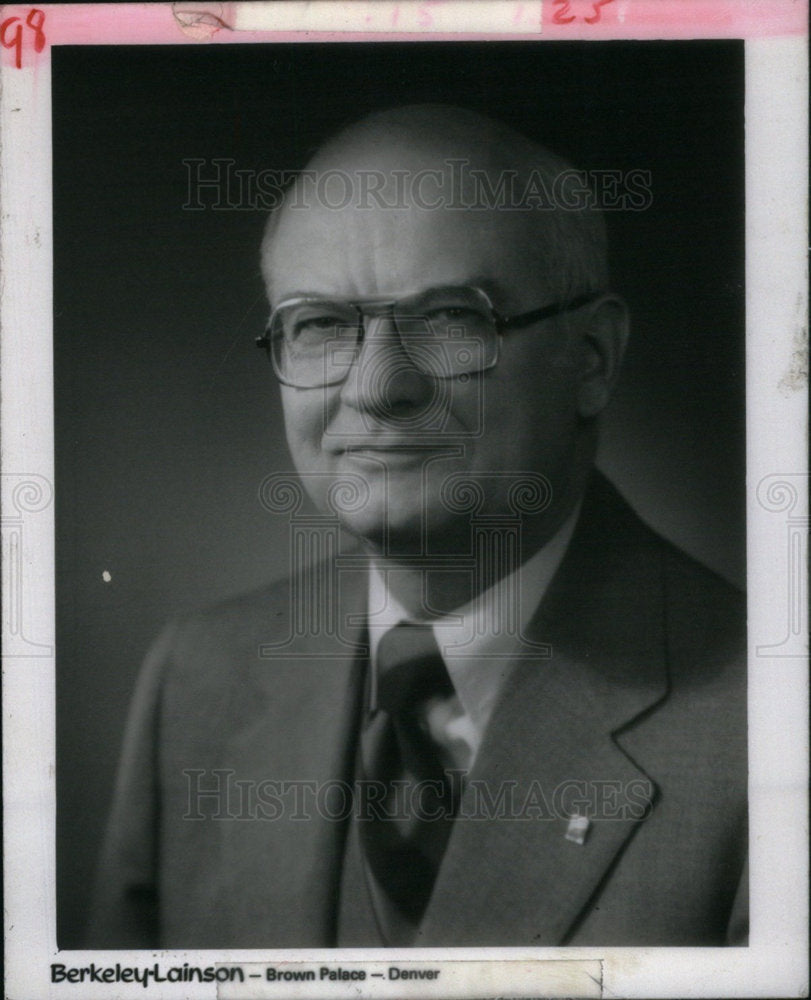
[415,476,667,945]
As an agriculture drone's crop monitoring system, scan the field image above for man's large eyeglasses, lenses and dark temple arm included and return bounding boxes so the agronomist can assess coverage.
[256,287,601,389]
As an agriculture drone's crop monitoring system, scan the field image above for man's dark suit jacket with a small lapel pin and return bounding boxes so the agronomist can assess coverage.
[88,477,747,948]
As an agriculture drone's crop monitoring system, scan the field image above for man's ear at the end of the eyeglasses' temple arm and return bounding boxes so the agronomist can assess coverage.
[577,295,629,419]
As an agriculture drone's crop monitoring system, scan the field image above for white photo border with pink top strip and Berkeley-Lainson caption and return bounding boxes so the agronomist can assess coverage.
[0,0,808,1000]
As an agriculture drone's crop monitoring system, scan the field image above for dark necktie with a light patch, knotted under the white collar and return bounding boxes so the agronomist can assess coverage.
[360,622,458,943]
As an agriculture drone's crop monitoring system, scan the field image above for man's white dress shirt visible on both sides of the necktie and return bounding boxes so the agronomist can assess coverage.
[369,505,580,772]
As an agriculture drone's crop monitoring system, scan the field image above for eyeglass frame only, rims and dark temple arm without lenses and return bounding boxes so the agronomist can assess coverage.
[255,285,606,389]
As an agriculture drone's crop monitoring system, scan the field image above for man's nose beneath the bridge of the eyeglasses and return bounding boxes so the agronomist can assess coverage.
[341,315,434,419]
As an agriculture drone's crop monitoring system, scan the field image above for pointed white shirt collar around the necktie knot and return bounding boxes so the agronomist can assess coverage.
[368,504,580,732]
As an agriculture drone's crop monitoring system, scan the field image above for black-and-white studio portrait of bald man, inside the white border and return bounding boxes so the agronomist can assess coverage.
[53,35,747,949]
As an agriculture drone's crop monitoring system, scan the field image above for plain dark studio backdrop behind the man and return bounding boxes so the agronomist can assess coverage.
[53,42,745,948]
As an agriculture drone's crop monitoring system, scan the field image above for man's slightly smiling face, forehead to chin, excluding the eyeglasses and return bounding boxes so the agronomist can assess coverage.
[268,164,578,553]
